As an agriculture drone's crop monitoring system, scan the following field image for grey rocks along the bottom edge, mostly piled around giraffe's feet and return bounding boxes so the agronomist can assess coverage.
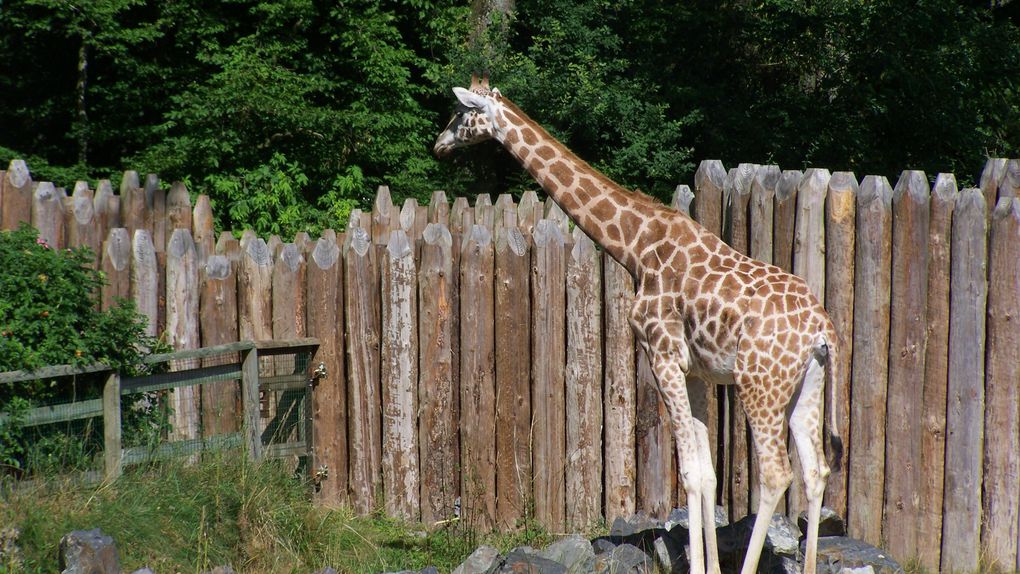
[53,508,903,574]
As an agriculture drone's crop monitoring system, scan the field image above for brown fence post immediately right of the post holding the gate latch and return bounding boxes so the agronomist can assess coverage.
[344,227,383,514]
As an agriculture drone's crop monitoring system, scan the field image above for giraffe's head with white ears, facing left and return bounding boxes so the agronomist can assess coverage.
[432,76,503,157]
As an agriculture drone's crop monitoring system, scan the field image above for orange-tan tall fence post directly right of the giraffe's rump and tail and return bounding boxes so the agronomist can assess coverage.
[825,171,860,516]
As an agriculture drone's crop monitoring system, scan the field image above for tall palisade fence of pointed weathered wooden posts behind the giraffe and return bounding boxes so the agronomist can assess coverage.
[0,159,1020,570]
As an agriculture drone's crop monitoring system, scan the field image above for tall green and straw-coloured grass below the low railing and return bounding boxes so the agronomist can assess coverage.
[0,454,518,574]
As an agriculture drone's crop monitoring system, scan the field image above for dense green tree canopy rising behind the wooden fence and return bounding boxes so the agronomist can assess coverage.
[0,0,1020,233]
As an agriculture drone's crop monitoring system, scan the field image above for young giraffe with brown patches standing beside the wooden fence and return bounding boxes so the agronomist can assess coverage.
[434,77,843,574]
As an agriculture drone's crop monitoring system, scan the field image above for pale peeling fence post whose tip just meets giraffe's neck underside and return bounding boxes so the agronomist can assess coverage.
[565,227,603,528]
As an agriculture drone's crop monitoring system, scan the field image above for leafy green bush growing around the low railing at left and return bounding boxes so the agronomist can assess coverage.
[0,225,161,469]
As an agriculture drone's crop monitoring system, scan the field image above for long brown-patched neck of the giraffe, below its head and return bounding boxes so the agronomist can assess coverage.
[493,98,666,276]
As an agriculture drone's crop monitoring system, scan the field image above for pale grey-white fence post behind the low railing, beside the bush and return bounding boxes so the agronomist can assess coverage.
[165,228,202,440]
